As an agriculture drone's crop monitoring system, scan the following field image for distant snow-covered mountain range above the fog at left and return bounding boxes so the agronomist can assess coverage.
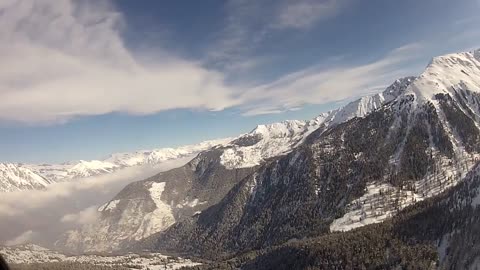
[0,138,231,192]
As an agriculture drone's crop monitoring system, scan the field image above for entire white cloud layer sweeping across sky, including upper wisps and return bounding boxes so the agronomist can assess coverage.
[0,0,478,124]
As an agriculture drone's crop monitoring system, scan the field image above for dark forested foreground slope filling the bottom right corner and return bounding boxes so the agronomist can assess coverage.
[199,163,480,270]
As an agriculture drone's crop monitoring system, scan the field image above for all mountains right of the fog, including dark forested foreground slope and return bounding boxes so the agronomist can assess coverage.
[2,50,480,269]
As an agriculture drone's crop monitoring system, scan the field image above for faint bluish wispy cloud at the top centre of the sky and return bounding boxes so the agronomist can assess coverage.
[207,0,355,72]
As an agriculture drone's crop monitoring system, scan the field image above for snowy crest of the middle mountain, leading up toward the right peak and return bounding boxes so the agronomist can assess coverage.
[220,77,415,169]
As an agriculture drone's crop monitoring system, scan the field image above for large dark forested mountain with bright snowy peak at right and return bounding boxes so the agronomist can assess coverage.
[144,49,480,258]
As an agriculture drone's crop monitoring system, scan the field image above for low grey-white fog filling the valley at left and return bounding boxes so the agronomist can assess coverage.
[0,157,192,248]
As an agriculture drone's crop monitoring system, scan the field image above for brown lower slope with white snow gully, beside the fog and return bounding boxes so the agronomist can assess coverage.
[56,148,253,253]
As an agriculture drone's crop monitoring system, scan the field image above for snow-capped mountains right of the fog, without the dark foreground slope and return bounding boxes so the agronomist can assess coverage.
[13,48,480,262]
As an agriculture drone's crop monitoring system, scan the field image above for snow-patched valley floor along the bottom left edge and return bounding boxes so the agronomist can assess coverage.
[0,244,200,270]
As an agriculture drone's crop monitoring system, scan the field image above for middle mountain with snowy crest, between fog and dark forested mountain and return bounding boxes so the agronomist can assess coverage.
[56,77,414,252]
